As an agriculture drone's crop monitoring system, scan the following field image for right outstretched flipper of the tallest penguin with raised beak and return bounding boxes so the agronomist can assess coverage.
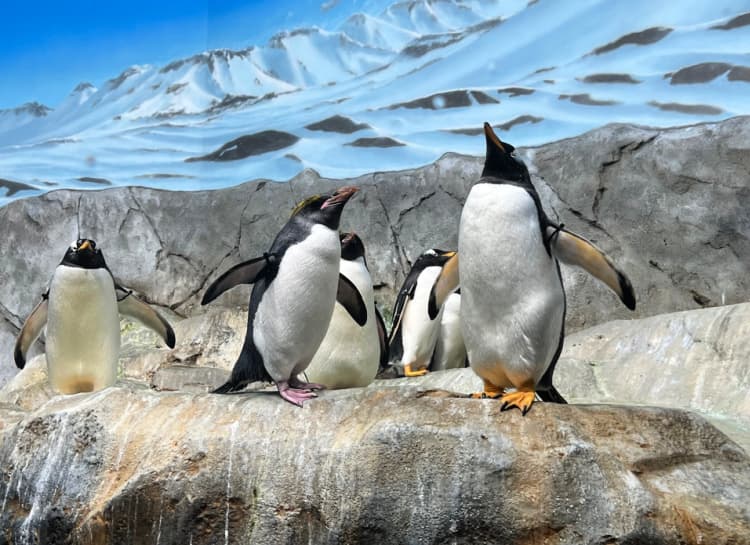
[547,226,635,310]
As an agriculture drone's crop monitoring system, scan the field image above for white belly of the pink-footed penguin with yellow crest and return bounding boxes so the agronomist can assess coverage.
[253,225,341,382]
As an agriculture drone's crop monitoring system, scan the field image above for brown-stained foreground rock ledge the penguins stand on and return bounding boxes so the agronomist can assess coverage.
[0,385,750,545]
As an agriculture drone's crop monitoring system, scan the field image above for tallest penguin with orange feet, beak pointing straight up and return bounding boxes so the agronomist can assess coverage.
[429,123,635,414]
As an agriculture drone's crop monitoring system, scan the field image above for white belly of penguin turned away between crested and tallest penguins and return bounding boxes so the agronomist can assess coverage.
[401,267,443,369]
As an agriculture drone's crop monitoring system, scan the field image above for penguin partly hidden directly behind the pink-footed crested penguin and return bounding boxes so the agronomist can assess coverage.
[305,233,388,388]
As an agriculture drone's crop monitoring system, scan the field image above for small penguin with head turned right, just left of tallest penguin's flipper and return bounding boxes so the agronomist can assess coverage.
[388,248,456,377]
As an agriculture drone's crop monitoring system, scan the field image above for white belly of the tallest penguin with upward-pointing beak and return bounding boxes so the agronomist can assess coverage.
[458,183,565,387]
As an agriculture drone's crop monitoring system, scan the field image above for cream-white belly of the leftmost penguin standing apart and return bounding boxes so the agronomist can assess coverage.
[46,265,120,394]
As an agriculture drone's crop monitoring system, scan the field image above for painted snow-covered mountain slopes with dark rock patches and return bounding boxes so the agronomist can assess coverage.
[0,0,750,203]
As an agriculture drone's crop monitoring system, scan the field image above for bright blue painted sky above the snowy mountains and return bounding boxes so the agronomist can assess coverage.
[0,0,387,109]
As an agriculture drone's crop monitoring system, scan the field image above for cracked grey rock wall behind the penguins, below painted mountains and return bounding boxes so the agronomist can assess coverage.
[0,118,750,382]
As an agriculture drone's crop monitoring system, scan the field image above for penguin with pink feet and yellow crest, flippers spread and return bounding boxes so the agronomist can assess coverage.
[201,187,367,407]
